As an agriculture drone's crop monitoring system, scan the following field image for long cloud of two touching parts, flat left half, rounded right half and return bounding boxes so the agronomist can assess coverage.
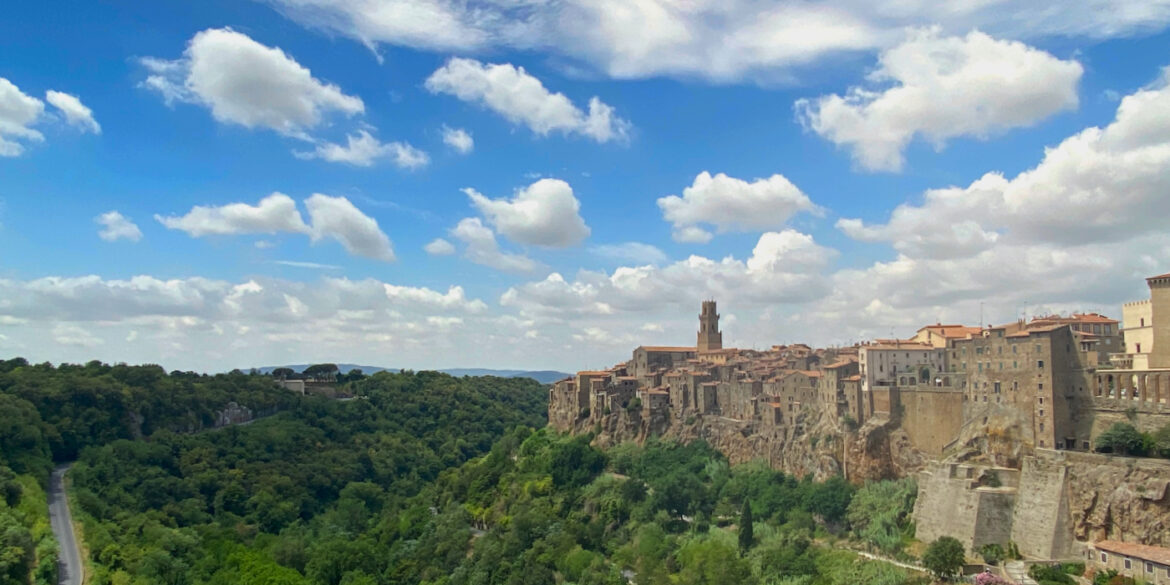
[154,193,394,262]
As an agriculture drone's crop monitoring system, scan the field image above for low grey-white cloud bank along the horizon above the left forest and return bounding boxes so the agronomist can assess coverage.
[0,275,514,371]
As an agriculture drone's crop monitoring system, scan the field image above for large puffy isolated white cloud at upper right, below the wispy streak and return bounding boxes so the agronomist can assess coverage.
[796,28,1083,171]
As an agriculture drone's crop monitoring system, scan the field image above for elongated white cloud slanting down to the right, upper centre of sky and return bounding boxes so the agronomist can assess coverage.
[426,57,629,143]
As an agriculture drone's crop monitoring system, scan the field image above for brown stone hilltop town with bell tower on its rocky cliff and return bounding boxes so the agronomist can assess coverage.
[549,274,1170,575]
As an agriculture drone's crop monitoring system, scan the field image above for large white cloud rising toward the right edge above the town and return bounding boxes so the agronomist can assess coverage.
[838,62,1170,259]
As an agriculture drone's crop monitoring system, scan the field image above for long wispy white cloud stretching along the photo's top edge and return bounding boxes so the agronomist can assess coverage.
[265,0,1170,81]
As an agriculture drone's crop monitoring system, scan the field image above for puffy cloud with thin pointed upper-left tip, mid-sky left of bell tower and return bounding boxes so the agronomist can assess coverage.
[463,179,590,248]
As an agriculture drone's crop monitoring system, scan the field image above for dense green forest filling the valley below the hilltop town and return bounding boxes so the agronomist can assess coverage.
[0,360,924,585]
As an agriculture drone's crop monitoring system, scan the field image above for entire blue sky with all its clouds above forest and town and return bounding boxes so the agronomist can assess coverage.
[0,0,1170,371]
